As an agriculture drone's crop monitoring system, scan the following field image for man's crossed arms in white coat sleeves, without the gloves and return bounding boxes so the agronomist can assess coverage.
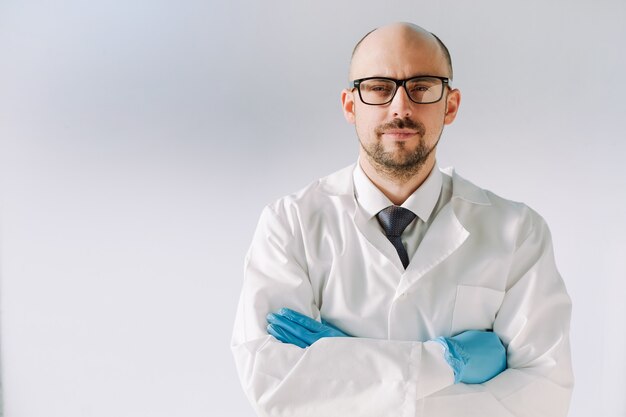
[232,203,572,417]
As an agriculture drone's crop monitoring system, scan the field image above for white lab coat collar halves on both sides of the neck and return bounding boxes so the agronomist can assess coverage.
[318,163,491,205]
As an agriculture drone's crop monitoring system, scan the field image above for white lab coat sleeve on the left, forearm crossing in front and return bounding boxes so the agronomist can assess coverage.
[231,208,454,417]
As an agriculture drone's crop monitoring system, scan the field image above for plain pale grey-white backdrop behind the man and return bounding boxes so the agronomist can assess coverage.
[0,0,626,417]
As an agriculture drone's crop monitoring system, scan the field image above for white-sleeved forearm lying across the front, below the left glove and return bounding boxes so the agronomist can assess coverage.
[233,330,454,417]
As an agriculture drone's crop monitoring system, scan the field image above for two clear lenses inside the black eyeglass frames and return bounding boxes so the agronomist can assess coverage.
[359,77,443,104]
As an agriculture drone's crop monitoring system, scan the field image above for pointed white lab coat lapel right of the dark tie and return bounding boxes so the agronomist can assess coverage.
[396,198,469,296]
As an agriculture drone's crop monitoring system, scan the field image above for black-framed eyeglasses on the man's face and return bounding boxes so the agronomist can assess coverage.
[350,75,450,106]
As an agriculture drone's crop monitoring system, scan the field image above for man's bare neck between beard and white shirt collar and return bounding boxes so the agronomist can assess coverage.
[359,155,435,206]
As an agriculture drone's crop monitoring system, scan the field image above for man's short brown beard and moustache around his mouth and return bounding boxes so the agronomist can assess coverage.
[359,118,441,181]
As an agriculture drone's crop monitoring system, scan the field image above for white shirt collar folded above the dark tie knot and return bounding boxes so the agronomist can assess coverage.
[352,158,443,222]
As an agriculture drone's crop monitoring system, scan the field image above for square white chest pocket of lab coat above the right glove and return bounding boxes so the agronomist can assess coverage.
[450,285,504,335]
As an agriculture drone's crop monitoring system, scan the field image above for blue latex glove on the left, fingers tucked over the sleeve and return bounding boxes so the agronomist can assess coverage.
[267,308,349,349]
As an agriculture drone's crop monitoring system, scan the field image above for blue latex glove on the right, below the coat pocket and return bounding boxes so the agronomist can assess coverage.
[435,330,506,384]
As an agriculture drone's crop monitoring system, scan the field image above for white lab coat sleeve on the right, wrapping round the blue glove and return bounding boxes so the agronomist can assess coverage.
[424,208,574,417]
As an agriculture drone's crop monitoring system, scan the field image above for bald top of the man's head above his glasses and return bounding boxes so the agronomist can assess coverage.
[350,23,452,80]
